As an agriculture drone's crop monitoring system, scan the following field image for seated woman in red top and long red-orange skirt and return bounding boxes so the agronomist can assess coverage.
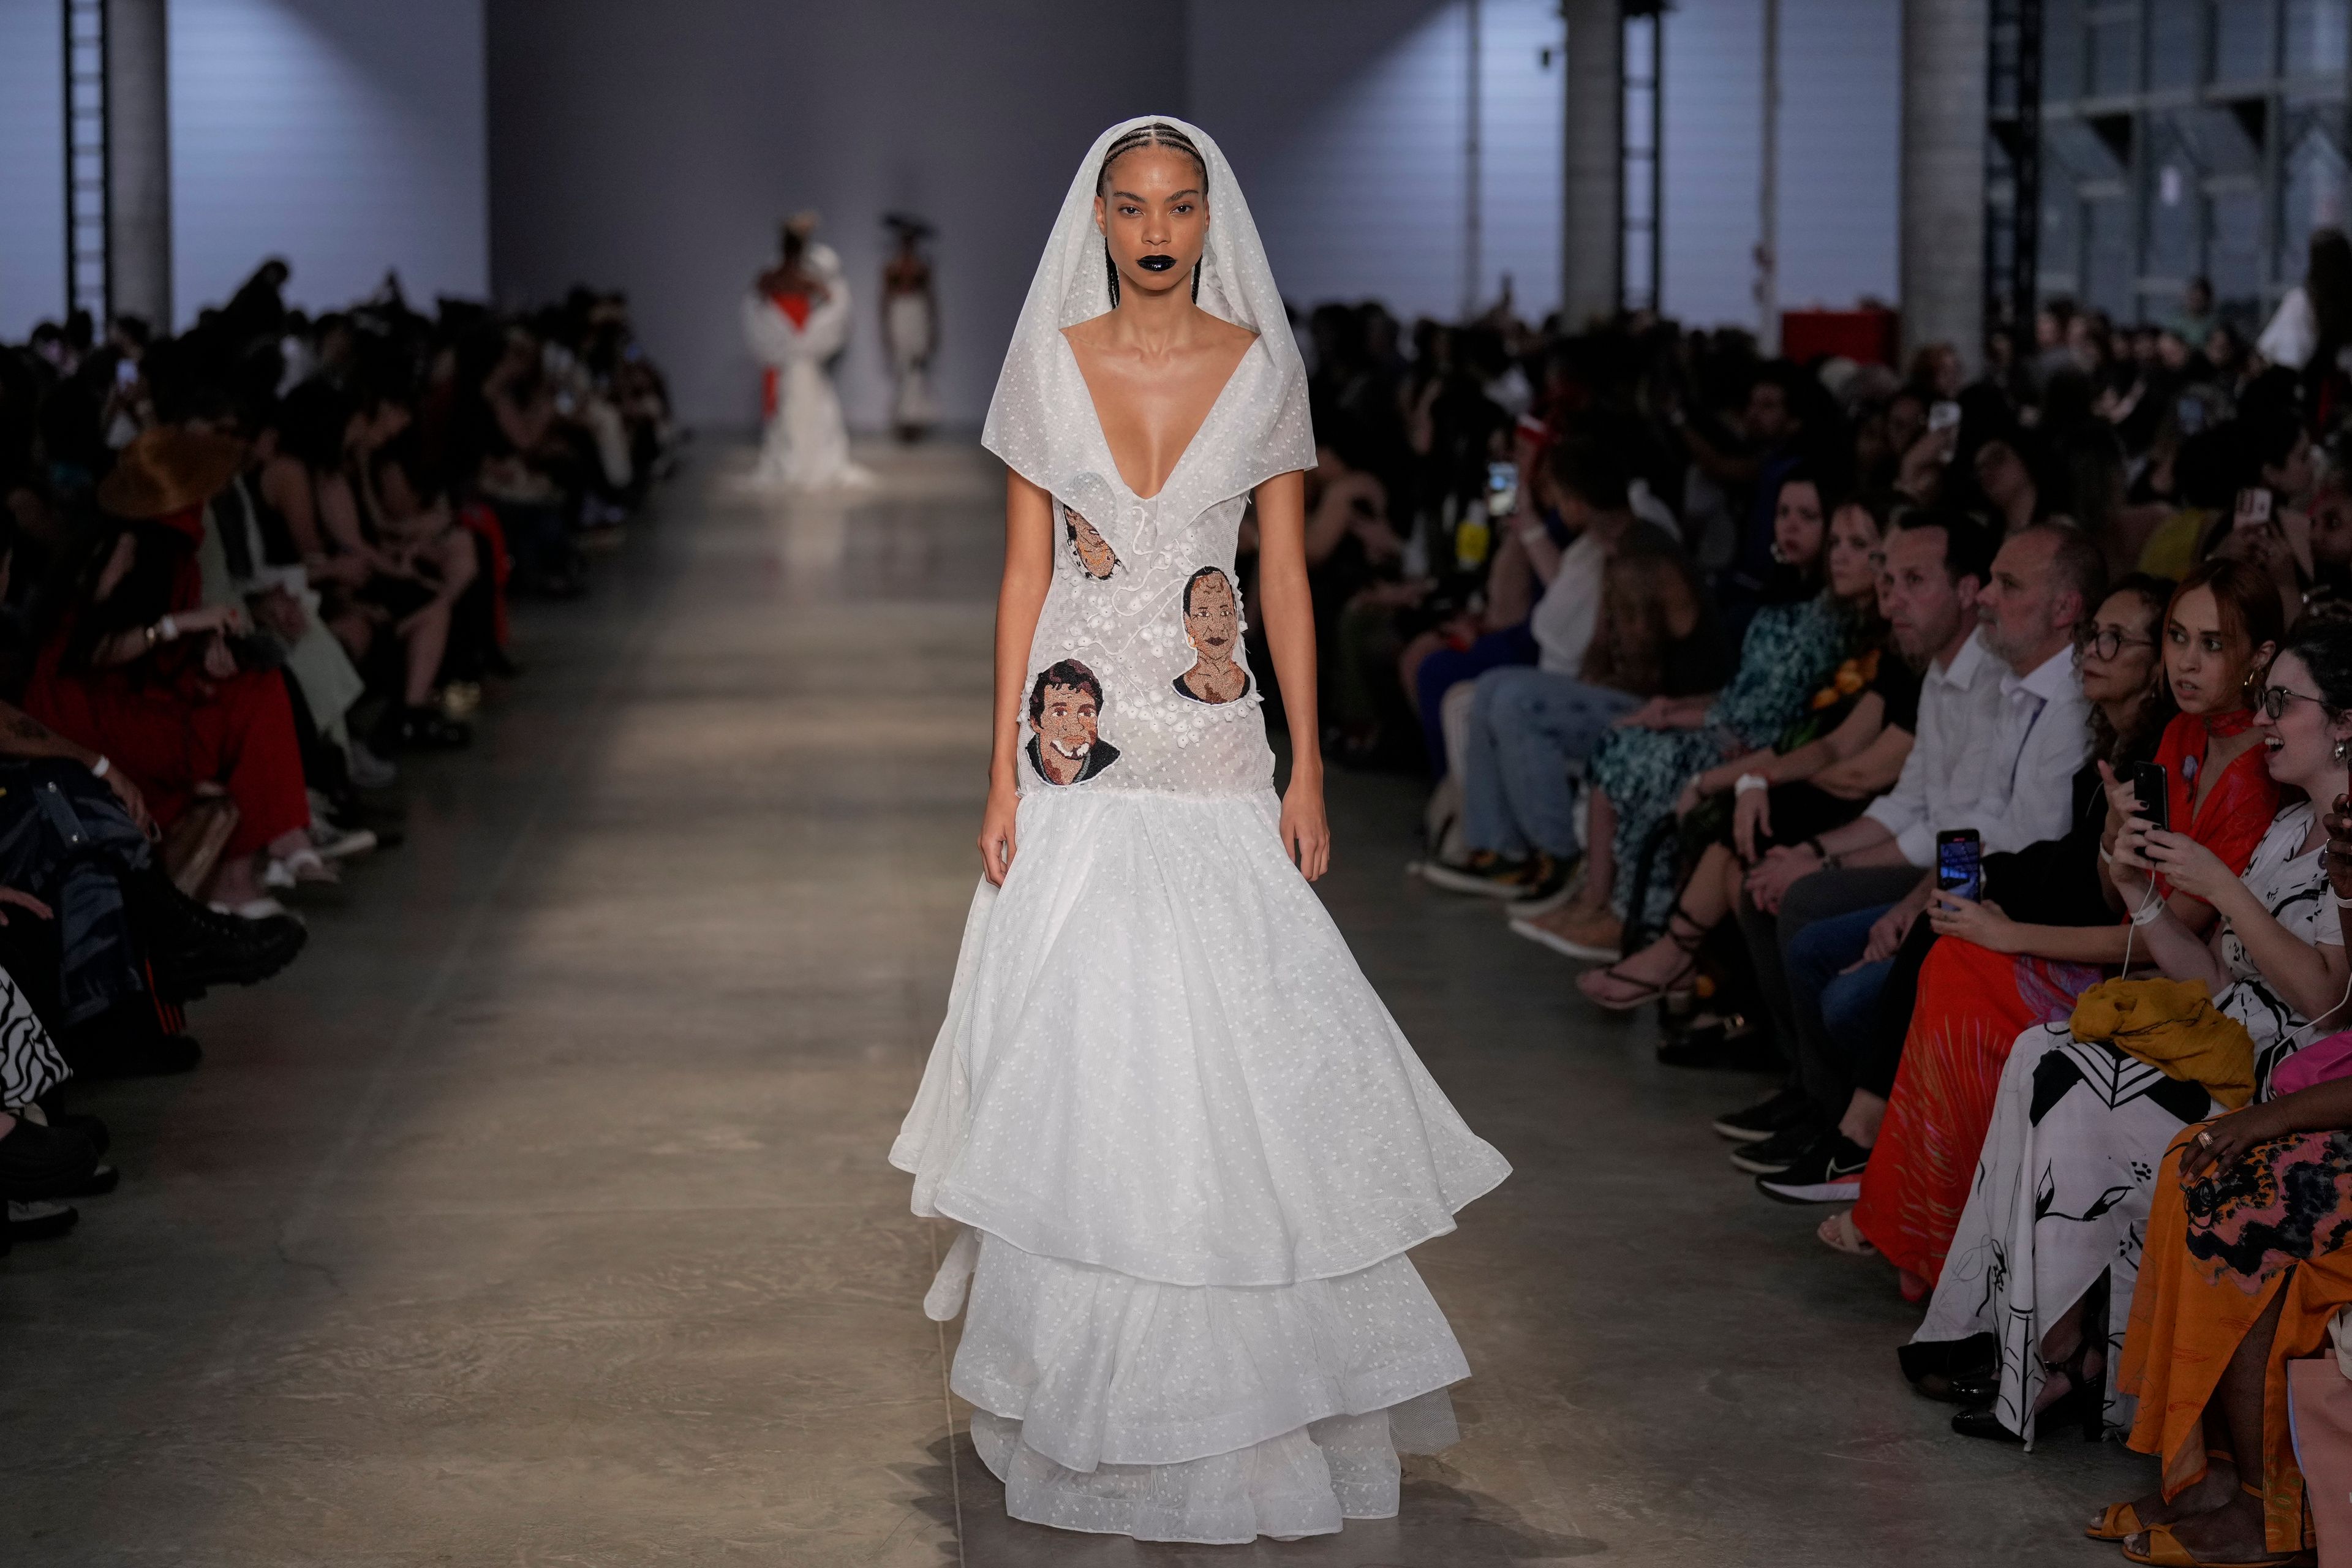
[1823,559,2284,1295]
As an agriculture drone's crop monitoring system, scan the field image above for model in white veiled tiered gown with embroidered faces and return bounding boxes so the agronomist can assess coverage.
[891,120,1507,1542]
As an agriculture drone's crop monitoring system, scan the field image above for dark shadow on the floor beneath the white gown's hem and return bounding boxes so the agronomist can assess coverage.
[901,1425,1609,1568]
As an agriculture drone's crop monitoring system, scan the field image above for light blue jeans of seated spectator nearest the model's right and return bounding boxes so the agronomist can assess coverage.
[1463,665,1642,858]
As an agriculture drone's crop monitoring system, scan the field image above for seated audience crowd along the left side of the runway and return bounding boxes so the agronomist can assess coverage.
[0,258,677,1253]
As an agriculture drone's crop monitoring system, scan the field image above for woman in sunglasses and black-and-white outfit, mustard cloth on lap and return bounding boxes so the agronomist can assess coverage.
[1905,625,2352,1441]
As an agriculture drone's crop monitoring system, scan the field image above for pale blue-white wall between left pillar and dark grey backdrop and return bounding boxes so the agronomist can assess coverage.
[170,0,489,325]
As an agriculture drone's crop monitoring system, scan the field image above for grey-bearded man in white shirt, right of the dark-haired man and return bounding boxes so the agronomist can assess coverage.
[1733,524,2105,1201]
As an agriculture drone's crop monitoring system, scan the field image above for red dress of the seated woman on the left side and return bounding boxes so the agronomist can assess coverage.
[23,540,311,856]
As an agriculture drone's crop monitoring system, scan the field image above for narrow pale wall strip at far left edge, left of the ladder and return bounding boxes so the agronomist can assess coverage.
[0,0,66,341]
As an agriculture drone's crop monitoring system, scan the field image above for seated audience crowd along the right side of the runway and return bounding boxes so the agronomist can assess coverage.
[1244,230,2352,1563]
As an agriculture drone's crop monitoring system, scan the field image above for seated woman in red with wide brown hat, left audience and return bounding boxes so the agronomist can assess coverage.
[23,428,317,914]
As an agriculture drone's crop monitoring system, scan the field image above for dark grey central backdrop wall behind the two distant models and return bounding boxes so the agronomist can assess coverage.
[489,0,1185,428]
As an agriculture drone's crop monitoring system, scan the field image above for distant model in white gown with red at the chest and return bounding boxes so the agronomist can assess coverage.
[743,211,873,489]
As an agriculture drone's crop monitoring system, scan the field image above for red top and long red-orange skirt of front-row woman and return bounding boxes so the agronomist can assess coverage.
[1853,712,2279,1284]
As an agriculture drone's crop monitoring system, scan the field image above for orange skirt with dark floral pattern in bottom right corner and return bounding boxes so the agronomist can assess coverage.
[2117,1126,2352,1551]
